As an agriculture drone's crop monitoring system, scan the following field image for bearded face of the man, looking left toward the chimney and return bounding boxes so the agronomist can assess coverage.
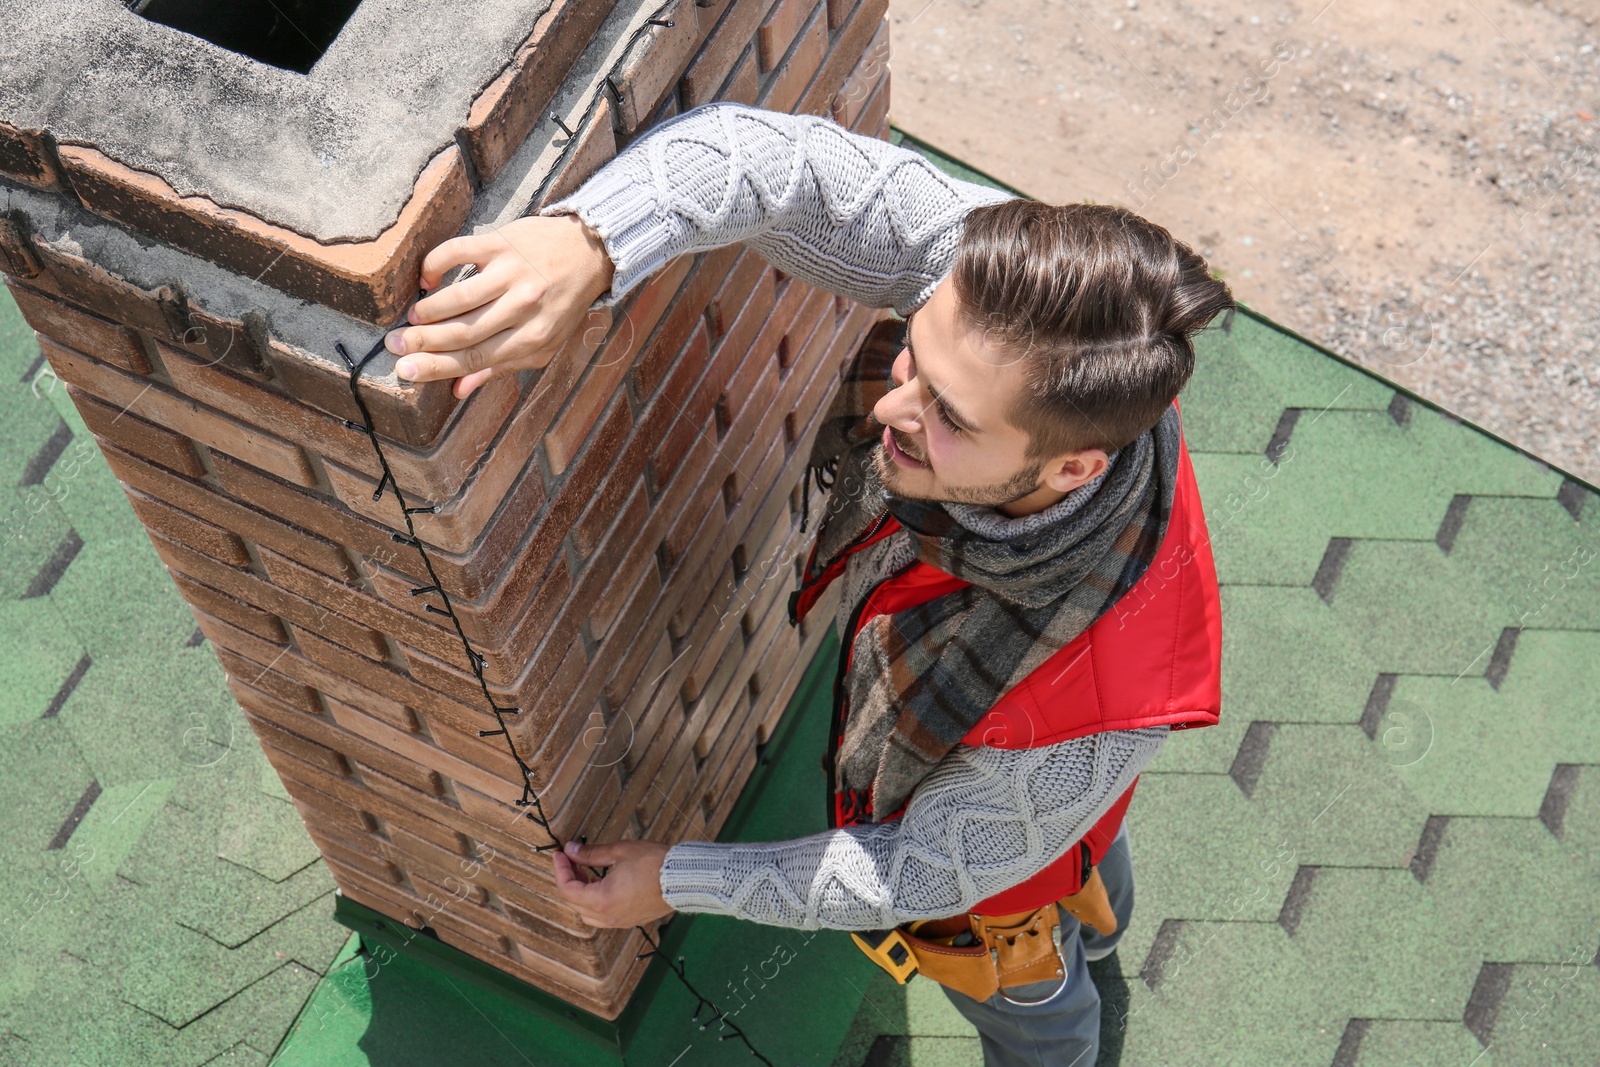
[872,278,1106,515]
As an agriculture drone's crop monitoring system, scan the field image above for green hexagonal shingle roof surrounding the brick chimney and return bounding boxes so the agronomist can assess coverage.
[0,129,1600,1067]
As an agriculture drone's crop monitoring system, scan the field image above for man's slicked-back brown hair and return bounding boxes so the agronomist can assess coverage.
[952,200,1234,461]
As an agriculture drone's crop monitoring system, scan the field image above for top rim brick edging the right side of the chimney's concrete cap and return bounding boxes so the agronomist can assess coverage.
[462,0,616,184]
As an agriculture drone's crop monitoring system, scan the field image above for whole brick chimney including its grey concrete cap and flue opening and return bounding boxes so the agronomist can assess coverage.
[0,0,888,1019]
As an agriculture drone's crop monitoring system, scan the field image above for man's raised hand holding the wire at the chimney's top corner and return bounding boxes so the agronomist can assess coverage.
[384,214,613,398]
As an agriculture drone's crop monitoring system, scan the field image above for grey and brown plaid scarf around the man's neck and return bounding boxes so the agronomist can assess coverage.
[802,320,1179,822]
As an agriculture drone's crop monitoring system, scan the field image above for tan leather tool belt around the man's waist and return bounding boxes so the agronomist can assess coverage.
[850,845,1117,1005]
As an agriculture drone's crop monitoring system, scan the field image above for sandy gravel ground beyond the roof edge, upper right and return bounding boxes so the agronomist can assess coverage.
[890,0,1600,483]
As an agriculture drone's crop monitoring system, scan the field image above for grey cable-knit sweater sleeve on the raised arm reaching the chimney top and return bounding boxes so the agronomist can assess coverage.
[539,102,1008,315]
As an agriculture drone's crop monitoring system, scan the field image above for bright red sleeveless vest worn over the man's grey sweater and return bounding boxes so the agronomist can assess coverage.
[794,409,1222,915]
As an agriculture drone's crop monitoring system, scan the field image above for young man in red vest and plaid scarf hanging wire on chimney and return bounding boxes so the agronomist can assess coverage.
[380,104,1232,1067]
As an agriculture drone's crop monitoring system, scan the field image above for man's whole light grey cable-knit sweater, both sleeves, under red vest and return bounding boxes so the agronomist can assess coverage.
[541,104,1168,929]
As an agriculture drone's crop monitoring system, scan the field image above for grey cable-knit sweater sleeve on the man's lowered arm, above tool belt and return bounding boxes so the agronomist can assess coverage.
[661,726,1168,929]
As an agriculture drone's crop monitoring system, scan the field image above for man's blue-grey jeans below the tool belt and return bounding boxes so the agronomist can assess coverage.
[941,819,1133,1067]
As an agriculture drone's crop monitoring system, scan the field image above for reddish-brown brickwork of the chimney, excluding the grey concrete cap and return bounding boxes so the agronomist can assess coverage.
[0,0,888,1017]
